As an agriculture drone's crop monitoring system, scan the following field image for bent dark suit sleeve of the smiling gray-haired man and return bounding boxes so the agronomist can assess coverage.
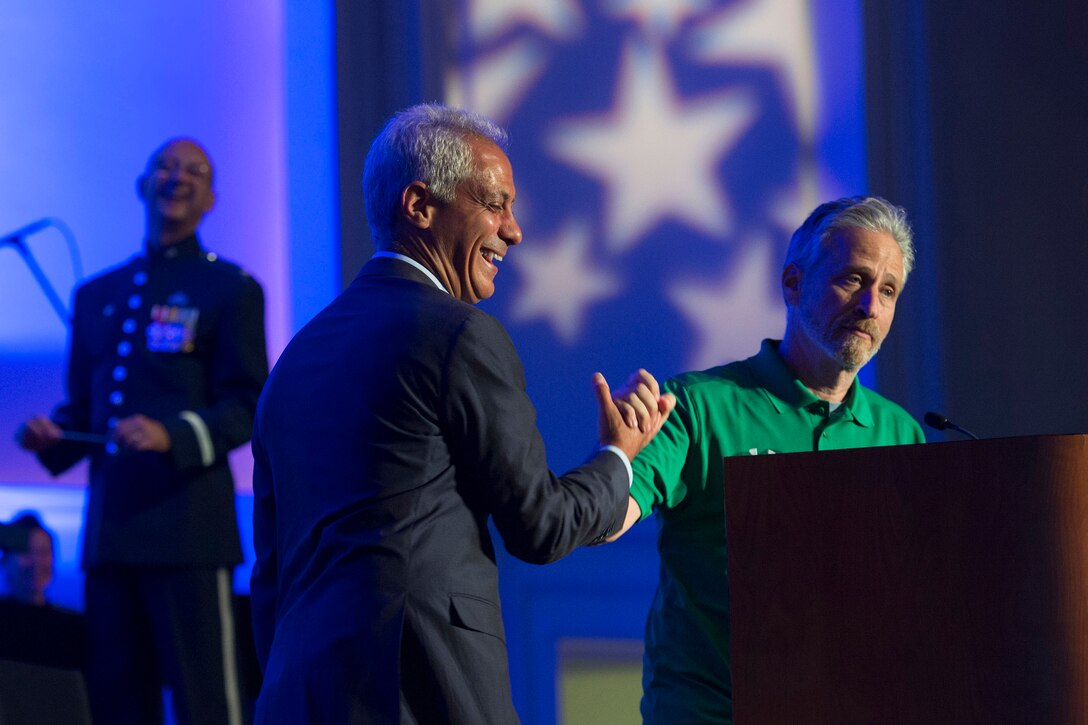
[441,314,628,563]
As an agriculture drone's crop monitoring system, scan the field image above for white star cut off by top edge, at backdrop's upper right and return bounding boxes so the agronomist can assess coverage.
[690,0,819,144]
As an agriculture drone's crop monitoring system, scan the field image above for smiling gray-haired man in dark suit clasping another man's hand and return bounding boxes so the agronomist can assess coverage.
[252,106,672,725]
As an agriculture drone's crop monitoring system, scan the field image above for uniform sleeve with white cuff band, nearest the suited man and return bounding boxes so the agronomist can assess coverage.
[163,274,268,470]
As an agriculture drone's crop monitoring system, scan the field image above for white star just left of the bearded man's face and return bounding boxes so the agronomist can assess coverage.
[667,237,786,370]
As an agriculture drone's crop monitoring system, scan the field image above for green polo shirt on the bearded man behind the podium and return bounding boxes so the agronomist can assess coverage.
[631,340,925,725]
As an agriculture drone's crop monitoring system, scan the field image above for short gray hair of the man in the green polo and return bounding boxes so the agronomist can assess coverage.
[783,196,914,284]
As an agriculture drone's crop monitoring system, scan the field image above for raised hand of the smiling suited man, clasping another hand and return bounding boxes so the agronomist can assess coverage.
[593,370,676,460]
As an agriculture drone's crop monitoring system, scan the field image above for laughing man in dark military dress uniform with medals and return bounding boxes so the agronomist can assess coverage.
[18,139,268,724]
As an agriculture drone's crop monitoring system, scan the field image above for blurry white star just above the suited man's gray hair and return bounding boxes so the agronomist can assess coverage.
[446,38,551,123]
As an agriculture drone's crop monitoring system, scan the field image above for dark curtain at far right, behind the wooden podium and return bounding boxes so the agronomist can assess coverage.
[865,0,1088,440]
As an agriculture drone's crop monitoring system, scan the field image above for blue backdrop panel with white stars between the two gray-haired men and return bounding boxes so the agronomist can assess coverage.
[446,0,866,468]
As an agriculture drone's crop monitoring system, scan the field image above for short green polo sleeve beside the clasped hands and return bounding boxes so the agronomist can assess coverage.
[631,378,700,520]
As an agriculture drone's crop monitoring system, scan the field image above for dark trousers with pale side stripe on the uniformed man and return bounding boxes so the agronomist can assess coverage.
[86,566,242,725]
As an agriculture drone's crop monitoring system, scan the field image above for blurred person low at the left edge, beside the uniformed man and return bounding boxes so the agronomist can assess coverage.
[0,512,87,669]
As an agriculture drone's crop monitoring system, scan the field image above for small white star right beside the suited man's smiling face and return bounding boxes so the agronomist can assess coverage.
[510,221,620,345]
